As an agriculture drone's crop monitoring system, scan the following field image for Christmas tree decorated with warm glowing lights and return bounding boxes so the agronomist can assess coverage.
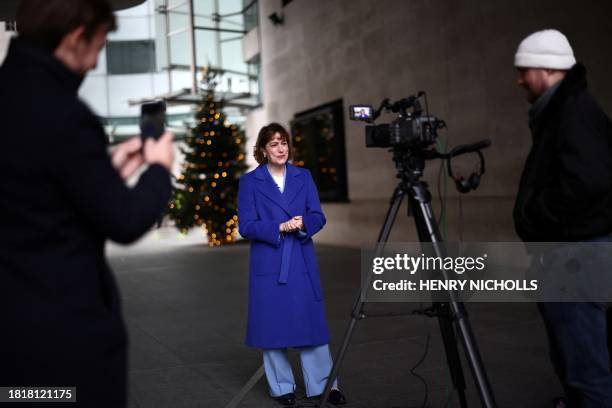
[168,72,247,246]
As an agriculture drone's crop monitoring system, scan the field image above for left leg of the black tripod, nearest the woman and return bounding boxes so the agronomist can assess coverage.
[318,183,406,408]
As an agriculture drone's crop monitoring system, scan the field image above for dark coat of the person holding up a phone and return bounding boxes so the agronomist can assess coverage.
[0,40,171,408]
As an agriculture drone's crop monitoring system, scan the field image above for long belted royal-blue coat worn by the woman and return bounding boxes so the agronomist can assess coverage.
[238,164,329,349]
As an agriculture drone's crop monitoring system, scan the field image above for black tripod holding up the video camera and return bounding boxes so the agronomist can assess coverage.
[319,142,496,408]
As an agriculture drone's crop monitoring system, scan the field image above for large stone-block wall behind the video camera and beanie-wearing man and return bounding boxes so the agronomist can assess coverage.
[247,0,612,245]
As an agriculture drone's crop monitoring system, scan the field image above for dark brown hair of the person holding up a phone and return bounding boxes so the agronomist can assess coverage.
[17,0,117,51]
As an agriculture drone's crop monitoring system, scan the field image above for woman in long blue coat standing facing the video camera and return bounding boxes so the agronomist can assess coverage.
[238,123,346,405]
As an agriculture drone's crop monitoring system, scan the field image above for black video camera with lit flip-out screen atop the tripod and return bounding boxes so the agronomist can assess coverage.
[349,92,446,149]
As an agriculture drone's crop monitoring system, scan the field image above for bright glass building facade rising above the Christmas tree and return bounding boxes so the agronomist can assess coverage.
[157,0,260,106]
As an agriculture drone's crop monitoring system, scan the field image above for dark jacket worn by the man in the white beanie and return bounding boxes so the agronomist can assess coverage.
[514,64,612,242]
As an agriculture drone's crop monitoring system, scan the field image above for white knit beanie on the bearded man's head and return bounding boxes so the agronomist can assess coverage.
[514,30,576,70]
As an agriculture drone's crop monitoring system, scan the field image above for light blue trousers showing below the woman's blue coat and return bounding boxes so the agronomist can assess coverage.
[263,344,338,397]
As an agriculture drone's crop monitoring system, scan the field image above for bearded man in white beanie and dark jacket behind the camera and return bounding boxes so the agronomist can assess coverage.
[514,30,612,408]
